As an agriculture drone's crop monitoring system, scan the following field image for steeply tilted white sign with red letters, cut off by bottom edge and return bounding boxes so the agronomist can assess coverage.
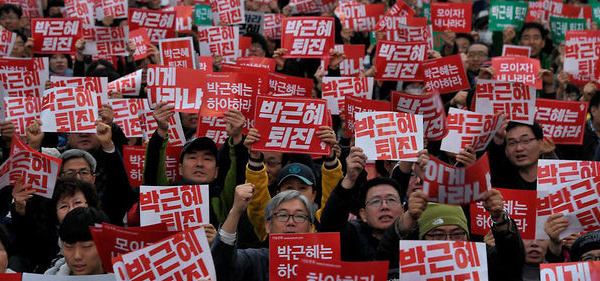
[112,227,217,280]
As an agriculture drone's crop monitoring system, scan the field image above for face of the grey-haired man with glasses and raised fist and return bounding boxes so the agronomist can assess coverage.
[265,198,311,234]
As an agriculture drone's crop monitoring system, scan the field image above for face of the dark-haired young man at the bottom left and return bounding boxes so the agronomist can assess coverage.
[63,240,104,275]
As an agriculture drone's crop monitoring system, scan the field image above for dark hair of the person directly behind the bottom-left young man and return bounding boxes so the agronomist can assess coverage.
[52,178,100,211]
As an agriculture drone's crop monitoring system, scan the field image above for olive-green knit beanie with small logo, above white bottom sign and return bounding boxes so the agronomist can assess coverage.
[418,203,469,240]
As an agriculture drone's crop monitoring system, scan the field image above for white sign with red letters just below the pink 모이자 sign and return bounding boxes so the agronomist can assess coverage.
[475,79,535,124]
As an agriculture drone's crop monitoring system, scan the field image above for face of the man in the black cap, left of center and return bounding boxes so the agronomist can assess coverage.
[179,150,218,184]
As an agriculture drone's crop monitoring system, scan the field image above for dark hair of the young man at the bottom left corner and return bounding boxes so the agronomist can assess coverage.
[58,207,108,244]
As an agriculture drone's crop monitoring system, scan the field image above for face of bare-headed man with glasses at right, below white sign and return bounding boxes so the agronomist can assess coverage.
[505,126,541,169]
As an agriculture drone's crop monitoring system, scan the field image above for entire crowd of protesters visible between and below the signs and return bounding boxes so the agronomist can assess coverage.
[0,0,600,280]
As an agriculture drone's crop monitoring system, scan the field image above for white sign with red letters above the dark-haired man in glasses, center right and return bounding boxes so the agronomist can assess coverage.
[354,111,423,161]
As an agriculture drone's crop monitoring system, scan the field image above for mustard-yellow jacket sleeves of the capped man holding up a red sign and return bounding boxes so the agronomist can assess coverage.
[246,160,344,242]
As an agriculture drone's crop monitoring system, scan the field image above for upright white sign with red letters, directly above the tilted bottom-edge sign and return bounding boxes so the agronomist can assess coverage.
[140,185,209,231]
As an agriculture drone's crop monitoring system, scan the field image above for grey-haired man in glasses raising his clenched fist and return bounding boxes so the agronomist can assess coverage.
[211,183,316,281]
